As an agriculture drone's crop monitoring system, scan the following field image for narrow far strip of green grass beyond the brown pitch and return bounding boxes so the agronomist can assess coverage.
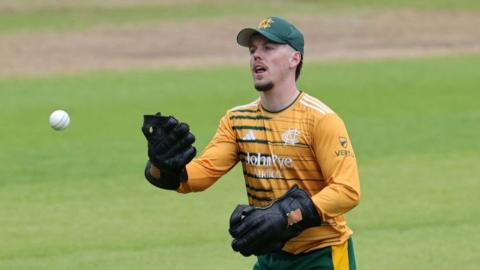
[0,0,480,33]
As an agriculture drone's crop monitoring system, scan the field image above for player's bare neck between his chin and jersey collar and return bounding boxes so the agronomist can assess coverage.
[260,80,300,112]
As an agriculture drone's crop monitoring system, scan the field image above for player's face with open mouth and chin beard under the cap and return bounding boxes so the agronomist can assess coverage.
[249,35,294,91]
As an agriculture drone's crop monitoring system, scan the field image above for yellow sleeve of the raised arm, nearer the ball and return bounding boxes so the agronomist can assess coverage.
[177,113,239,193]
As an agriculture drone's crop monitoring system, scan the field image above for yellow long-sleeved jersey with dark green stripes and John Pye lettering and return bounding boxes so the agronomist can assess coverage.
[178,92,360,254]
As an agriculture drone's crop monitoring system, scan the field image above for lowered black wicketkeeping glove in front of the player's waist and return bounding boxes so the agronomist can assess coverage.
[229,185,322,256]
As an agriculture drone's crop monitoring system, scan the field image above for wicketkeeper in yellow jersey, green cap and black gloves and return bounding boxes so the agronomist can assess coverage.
[142,17,360,270]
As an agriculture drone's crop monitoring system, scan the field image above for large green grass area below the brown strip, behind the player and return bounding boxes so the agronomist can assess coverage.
[0,55,480,270]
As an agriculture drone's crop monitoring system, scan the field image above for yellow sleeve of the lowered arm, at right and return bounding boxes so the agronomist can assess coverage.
[312,114,360,219]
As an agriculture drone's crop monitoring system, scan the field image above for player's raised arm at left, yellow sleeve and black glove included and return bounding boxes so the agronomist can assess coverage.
[142,110,238,193]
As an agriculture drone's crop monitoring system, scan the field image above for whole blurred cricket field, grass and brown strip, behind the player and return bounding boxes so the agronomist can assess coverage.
[0,0,480,270]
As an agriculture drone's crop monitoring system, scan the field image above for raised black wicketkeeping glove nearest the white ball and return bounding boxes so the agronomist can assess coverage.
[142,113,197,189]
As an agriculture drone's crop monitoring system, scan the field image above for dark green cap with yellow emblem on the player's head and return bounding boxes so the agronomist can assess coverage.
[237,17,304,56]
